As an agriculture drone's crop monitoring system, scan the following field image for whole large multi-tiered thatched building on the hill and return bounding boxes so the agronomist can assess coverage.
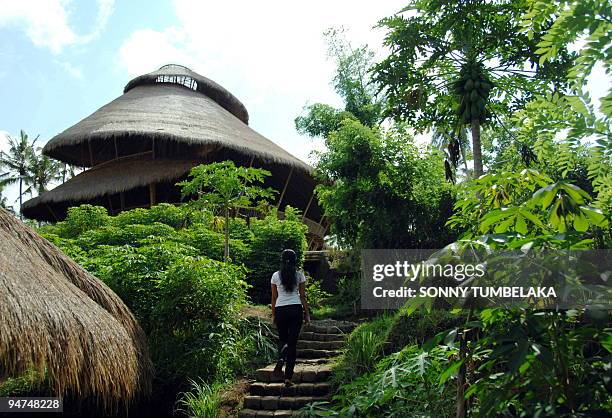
[23,65,326,247]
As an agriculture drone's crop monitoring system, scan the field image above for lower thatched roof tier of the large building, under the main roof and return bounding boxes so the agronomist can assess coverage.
[23,157,196,211]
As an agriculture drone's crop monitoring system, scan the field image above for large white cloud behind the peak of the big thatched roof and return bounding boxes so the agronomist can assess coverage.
[118,0,405,159]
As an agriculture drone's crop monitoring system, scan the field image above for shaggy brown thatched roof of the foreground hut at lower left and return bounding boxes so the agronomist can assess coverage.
[0,209,152,407]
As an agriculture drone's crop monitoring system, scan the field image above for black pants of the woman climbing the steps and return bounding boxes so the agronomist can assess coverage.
[275,304,302,379]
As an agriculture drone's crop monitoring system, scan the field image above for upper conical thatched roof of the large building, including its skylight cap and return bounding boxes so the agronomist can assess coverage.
[43,62,312,173]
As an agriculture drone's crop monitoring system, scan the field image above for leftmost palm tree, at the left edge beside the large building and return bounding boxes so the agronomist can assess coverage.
[0,130,38,219]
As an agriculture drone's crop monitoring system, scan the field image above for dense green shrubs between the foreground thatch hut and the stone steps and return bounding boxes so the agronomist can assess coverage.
[40,204,306,384]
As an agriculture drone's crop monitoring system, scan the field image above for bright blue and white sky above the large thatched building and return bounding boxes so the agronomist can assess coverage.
[0,0,405,211]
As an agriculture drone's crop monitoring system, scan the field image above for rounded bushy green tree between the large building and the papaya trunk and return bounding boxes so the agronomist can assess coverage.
[316,119,454,248]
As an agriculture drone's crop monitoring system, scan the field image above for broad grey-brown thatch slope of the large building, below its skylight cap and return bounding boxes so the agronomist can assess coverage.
[43,63,312,173]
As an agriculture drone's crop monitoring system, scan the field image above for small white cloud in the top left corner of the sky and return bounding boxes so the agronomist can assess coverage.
[0,0,115,54]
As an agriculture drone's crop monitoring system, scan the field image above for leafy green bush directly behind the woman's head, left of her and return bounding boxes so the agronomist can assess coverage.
[247,213,308,303]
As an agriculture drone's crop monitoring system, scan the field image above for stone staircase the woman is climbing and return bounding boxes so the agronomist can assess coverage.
[238,320,356,418]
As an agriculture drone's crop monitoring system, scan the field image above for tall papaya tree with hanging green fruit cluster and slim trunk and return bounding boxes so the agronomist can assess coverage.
[374,0,571,177]
